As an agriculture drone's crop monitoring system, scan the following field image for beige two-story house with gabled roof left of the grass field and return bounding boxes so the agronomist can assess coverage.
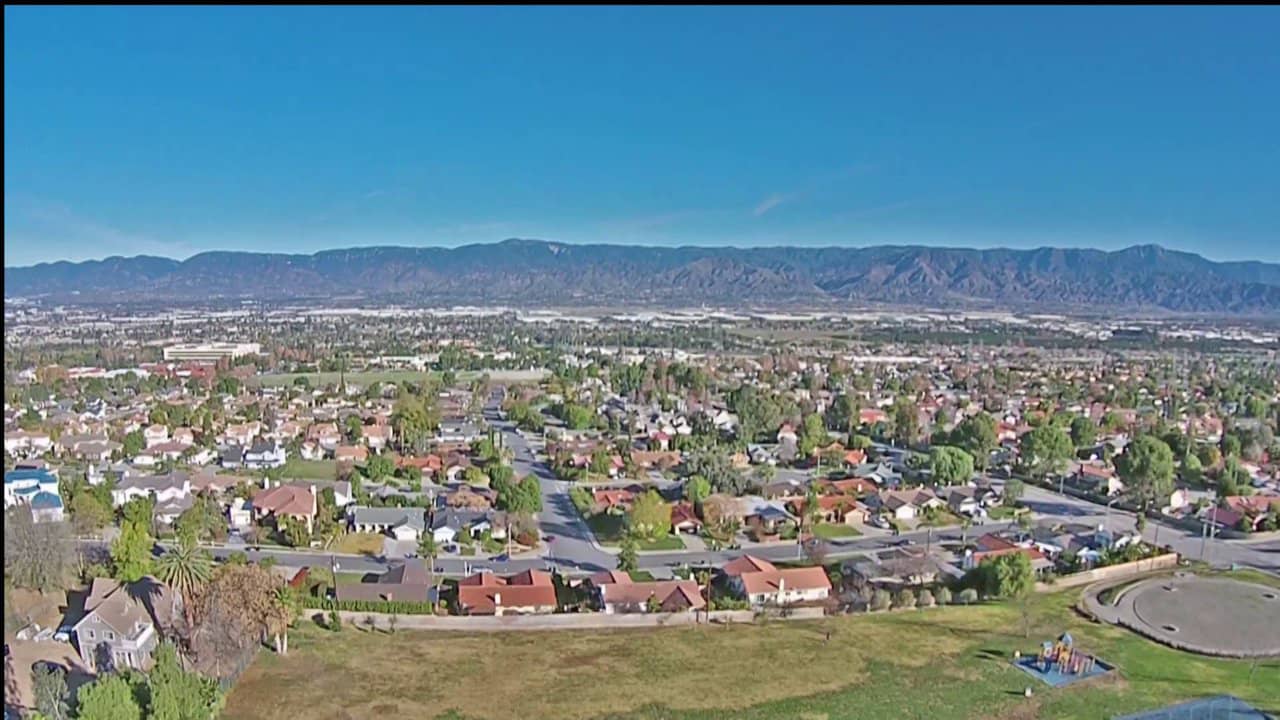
[73,577,182,673]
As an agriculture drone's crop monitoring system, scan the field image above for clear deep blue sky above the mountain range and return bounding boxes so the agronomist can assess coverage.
[4,6,1280,265]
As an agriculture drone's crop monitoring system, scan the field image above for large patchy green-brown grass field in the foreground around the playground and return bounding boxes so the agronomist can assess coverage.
[225,571,1280,720]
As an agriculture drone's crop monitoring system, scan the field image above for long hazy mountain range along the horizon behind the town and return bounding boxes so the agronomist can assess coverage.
[4,240,1280,315]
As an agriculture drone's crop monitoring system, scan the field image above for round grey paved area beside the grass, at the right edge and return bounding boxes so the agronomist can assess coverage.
[1116,575,1280,657]
